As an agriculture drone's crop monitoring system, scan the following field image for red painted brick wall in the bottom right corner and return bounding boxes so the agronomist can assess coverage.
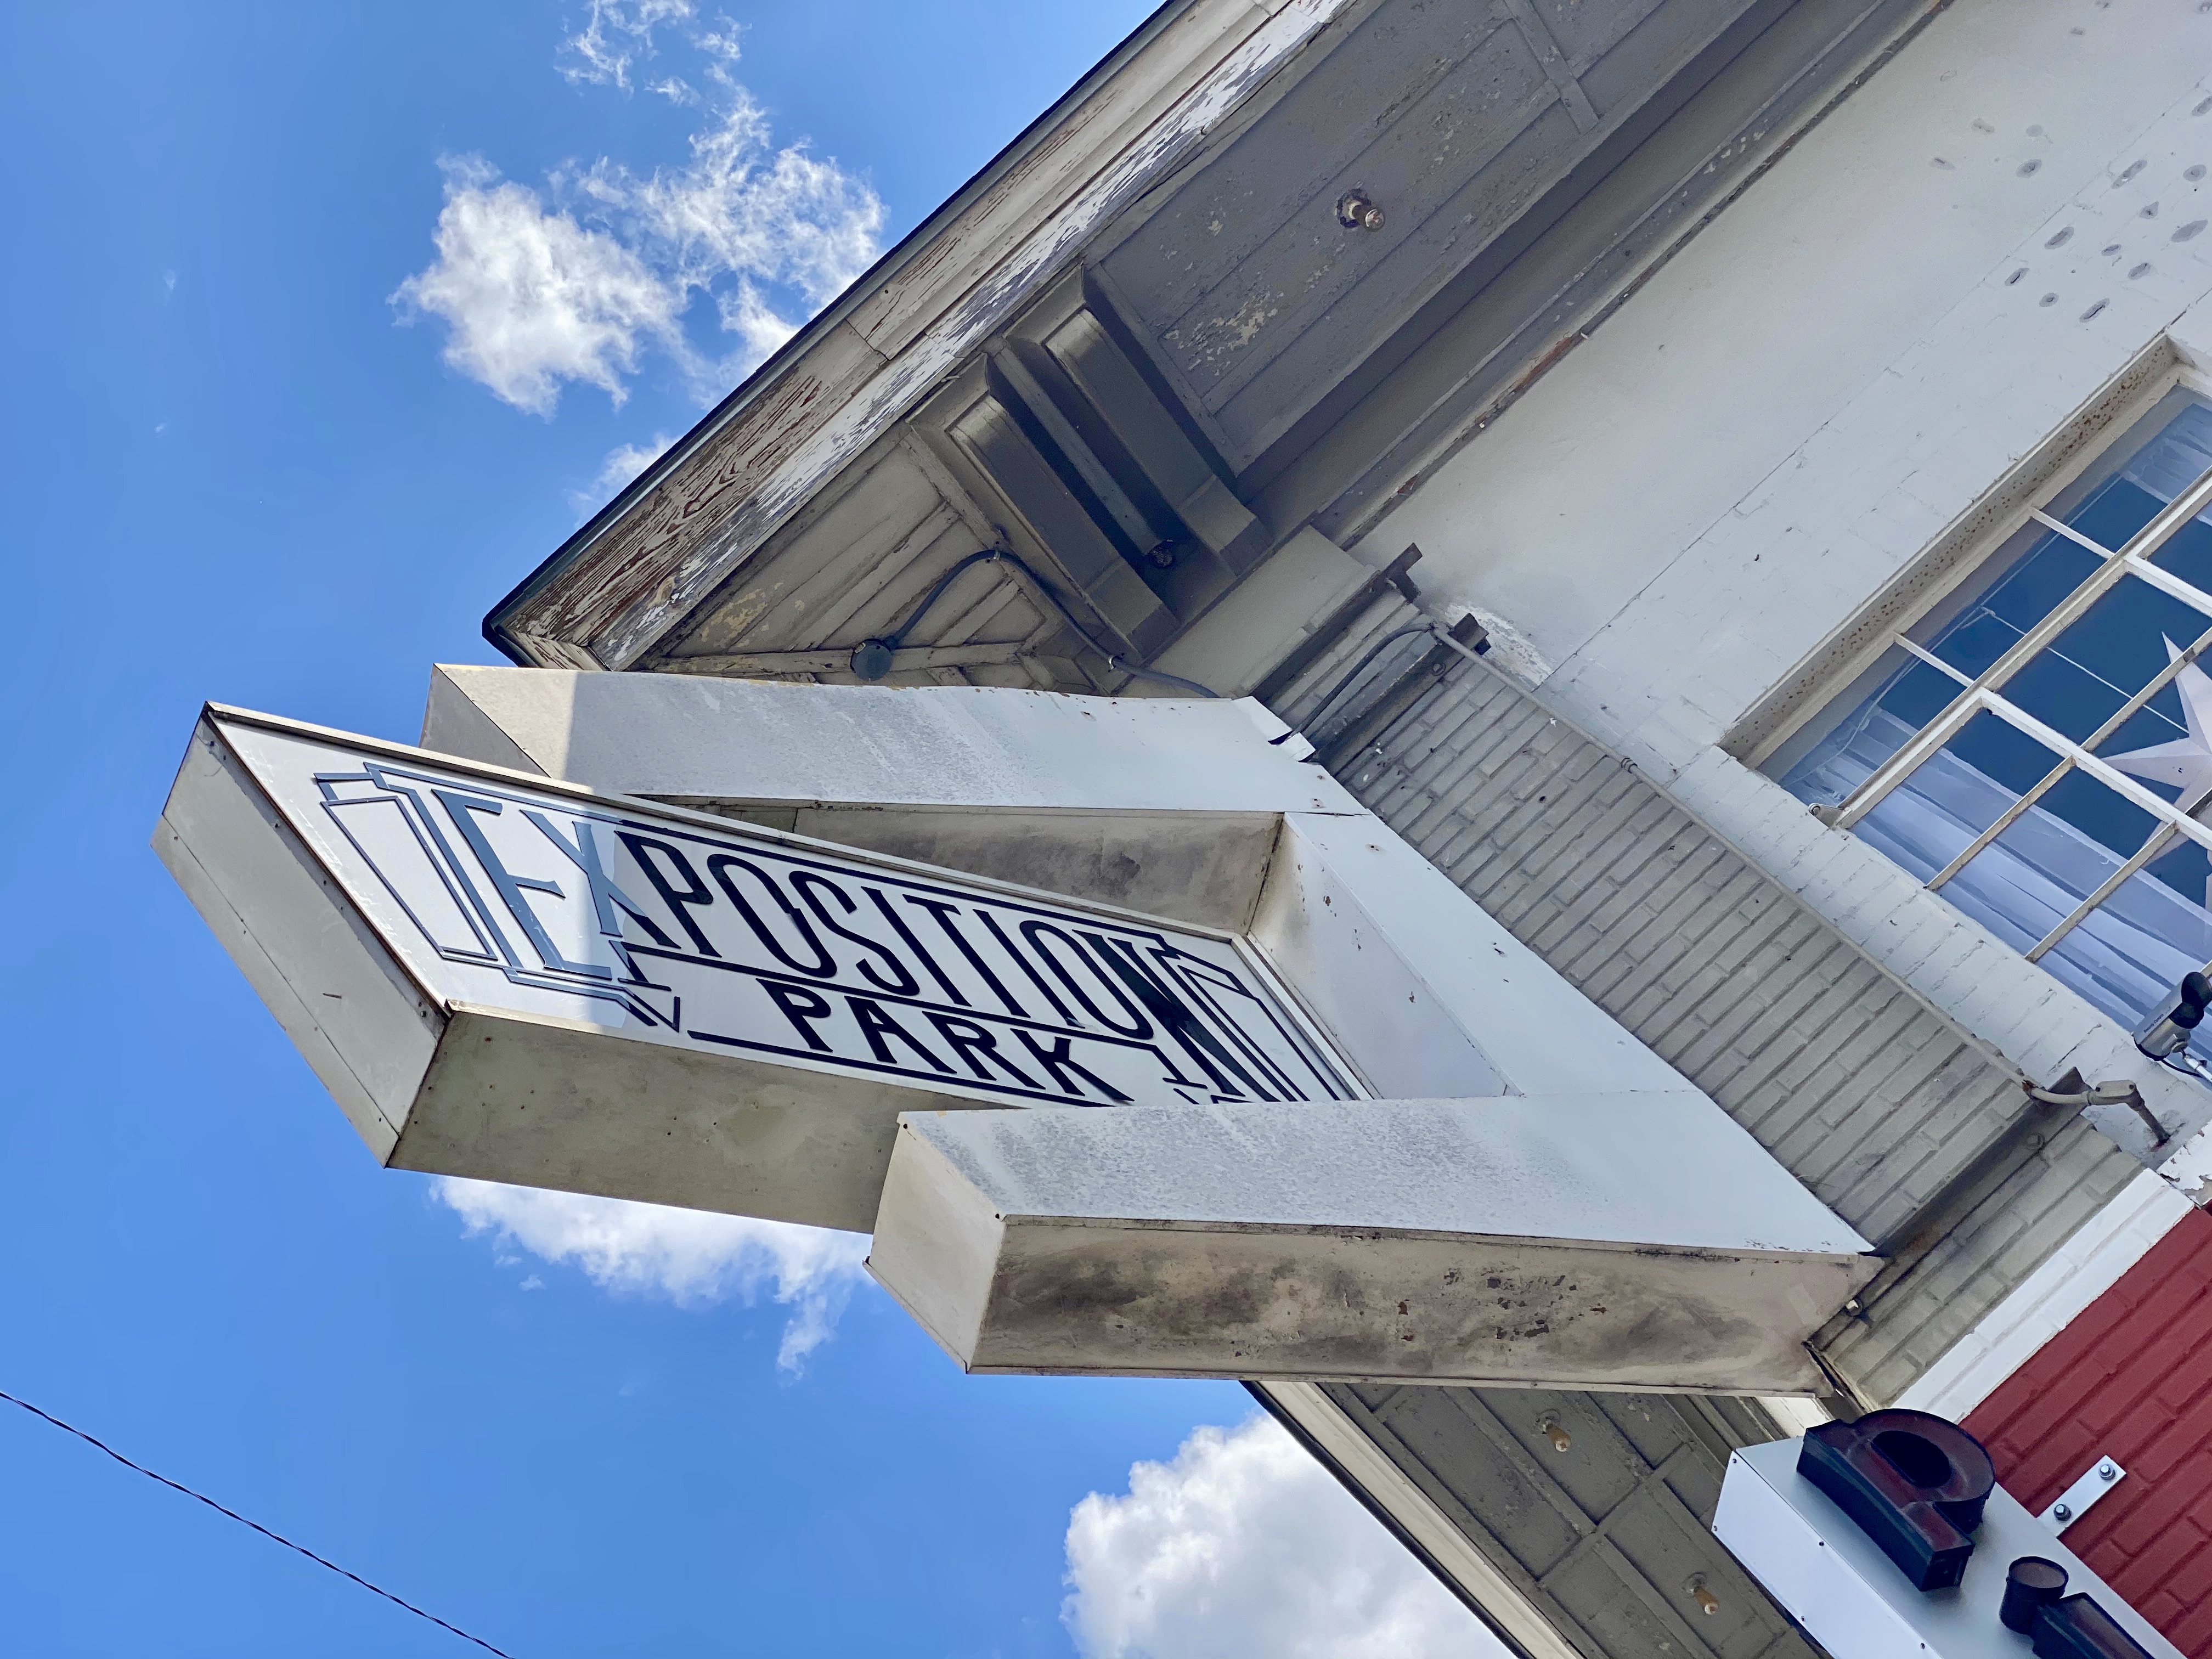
[1966,1210,2212,1659]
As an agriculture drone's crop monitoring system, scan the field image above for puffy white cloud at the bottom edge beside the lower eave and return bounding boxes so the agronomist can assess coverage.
[1059,1415,1504,1659]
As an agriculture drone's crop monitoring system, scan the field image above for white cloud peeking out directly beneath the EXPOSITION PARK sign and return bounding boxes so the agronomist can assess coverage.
[433,1175,867,1372]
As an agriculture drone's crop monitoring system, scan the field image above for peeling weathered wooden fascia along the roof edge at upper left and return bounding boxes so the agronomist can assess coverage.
[484,0,1358,668]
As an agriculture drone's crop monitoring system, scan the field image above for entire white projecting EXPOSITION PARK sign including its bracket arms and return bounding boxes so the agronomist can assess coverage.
[155,668,1876,1393]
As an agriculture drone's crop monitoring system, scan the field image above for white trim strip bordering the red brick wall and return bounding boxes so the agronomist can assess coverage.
[1895,1170,2192,1423]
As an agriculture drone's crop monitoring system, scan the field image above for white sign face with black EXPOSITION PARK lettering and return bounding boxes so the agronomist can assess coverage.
[221,721,1365,1106]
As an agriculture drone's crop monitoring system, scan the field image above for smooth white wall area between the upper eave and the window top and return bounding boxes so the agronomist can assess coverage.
[1378,0,2212,738]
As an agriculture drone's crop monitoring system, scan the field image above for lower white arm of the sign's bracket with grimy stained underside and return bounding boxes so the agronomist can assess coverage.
[870,1091,1878,1393]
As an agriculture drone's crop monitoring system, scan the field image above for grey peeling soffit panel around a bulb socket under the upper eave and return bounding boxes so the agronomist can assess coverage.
[1104,0,1745,469]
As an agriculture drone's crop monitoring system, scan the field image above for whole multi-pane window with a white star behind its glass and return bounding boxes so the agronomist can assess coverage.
[1765,392,2212,1024]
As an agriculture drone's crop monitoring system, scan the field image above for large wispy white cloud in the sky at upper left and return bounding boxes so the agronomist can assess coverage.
[392,17,885,416]
